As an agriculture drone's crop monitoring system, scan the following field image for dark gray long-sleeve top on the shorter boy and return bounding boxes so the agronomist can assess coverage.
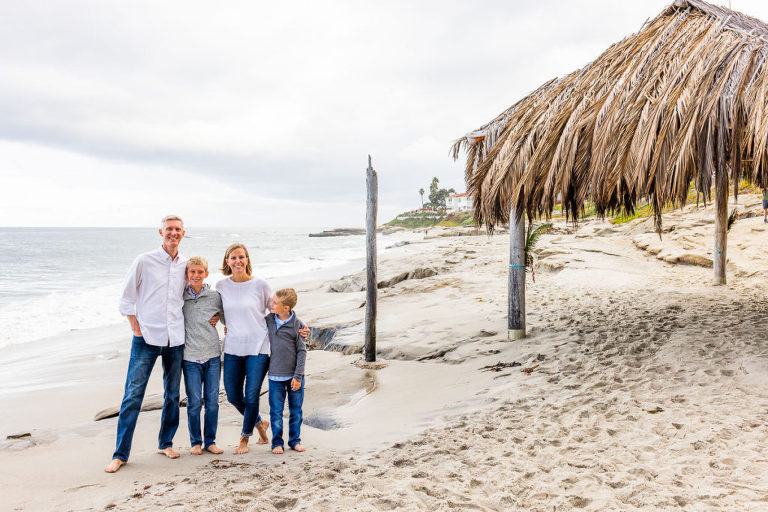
[265,313,307,380]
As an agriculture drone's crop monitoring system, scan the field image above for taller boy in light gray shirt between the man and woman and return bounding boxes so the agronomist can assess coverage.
[183,256,224,455]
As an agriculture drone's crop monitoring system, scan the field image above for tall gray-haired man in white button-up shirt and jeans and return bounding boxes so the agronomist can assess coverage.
[104,215,187,473]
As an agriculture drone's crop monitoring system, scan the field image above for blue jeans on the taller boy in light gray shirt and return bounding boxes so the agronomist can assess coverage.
[184,356,221,448]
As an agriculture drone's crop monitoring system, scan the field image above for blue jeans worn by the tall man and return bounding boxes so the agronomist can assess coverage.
[112,336,184,462]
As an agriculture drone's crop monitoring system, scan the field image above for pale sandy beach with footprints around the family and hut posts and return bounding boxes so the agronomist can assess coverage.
[0,195,768,511]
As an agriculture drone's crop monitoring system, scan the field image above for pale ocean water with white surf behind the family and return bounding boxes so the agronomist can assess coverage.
[0,227,365,347]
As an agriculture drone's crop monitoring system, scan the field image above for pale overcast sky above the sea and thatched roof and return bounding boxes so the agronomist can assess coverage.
[0,0,768,227]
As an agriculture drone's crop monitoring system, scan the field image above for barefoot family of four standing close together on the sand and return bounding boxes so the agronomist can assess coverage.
[104,215,309,473]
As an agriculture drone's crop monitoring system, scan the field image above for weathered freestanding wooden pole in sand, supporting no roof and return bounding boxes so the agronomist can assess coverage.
[365,155,379,363]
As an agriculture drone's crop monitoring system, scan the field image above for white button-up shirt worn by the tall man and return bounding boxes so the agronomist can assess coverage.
[120,247,187,347]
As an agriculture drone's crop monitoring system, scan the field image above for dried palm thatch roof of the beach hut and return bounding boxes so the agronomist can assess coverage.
[453,0,768,229]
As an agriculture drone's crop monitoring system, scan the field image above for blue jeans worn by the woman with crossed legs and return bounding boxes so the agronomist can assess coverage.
[224,354,269,437]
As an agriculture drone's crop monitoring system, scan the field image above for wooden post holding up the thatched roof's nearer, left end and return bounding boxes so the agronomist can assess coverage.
[507,206,525,340]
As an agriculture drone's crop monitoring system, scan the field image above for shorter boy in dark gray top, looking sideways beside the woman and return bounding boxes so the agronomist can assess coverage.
[266,288,307,454]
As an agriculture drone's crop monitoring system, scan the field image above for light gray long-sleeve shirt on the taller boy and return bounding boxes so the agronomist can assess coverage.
[183,284,224,361]
